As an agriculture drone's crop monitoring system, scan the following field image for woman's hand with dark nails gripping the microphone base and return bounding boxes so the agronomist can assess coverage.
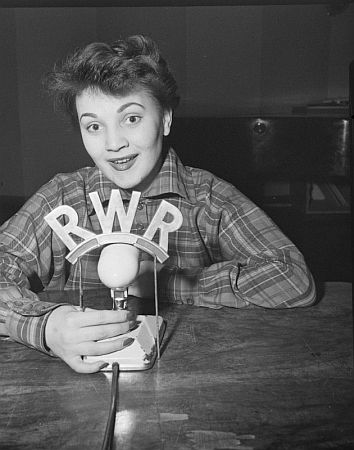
[45,305,136,373]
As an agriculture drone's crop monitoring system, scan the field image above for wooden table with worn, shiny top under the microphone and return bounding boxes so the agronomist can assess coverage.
[0,283,354,450]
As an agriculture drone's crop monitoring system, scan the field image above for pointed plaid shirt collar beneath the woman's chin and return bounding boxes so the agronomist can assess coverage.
[85,148,196,215]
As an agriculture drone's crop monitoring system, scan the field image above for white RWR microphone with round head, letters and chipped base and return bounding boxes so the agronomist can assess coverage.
[44,189,183,371]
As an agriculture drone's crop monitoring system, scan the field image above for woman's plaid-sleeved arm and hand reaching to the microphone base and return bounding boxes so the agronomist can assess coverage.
[0,187,135,373]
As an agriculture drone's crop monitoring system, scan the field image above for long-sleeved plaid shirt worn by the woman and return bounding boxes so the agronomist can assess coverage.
[0,149,315,351]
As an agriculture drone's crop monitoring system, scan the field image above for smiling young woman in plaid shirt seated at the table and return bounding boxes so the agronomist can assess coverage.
[0,36,315,372]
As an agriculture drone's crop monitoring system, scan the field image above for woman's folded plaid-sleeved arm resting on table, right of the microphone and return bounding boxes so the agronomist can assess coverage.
[154,202,316,308]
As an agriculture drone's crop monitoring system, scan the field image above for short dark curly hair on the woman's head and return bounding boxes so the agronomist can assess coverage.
[44,35,179,124]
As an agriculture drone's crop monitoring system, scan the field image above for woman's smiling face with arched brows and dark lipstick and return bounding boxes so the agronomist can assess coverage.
[76,89,172,191]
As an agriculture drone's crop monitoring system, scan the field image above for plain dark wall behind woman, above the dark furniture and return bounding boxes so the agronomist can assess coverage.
[0,4,354,196]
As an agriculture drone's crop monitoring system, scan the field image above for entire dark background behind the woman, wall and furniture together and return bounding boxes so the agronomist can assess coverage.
[0,1,354,280]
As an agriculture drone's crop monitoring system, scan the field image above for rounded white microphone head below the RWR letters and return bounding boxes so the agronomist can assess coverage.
[97,244,139,290]
